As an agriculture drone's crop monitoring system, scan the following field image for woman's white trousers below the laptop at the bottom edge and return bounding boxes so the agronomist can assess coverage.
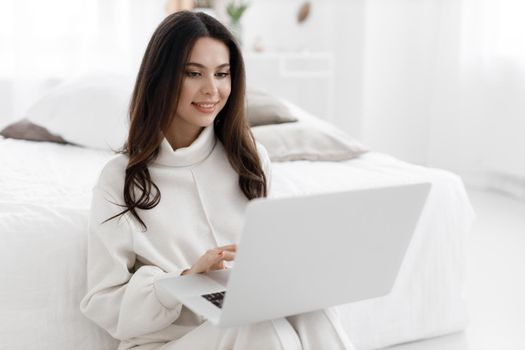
[159,309,355,350]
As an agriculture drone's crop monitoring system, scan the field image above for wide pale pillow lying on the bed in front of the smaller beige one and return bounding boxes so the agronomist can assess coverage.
[252,101,367,162]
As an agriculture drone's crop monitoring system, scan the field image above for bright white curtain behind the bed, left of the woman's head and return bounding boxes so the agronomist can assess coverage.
[0,0,165,126]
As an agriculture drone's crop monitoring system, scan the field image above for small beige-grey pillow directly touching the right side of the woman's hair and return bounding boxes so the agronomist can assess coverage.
[246,88,297,126]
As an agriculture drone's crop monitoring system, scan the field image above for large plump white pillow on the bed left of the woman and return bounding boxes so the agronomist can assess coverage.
[25,74,133,150]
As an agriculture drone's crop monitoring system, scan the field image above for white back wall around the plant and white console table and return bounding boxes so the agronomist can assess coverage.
[243,0,365,137]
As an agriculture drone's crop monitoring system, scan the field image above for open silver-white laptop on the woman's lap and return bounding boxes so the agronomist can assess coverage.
[152,183,430,327]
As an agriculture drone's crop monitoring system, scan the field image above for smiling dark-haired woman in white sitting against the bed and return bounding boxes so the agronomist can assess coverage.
[81,12,351,350]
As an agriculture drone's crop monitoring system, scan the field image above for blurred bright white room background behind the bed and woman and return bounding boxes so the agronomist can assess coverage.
[0,0,525,198]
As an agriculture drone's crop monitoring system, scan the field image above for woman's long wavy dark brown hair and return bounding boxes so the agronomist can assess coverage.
[106,11,267,231]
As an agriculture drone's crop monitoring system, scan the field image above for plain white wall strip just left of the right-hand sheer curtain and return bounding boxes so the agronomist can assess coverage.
[362,0,439,164]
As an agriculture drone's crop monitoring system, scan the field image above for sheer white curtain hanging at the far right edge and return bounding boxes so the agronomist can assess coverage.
[429,0,525,193]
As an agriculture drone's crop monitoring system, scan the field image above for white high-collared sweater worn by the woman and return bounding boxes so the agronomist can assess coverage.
[80,125,270,349]
